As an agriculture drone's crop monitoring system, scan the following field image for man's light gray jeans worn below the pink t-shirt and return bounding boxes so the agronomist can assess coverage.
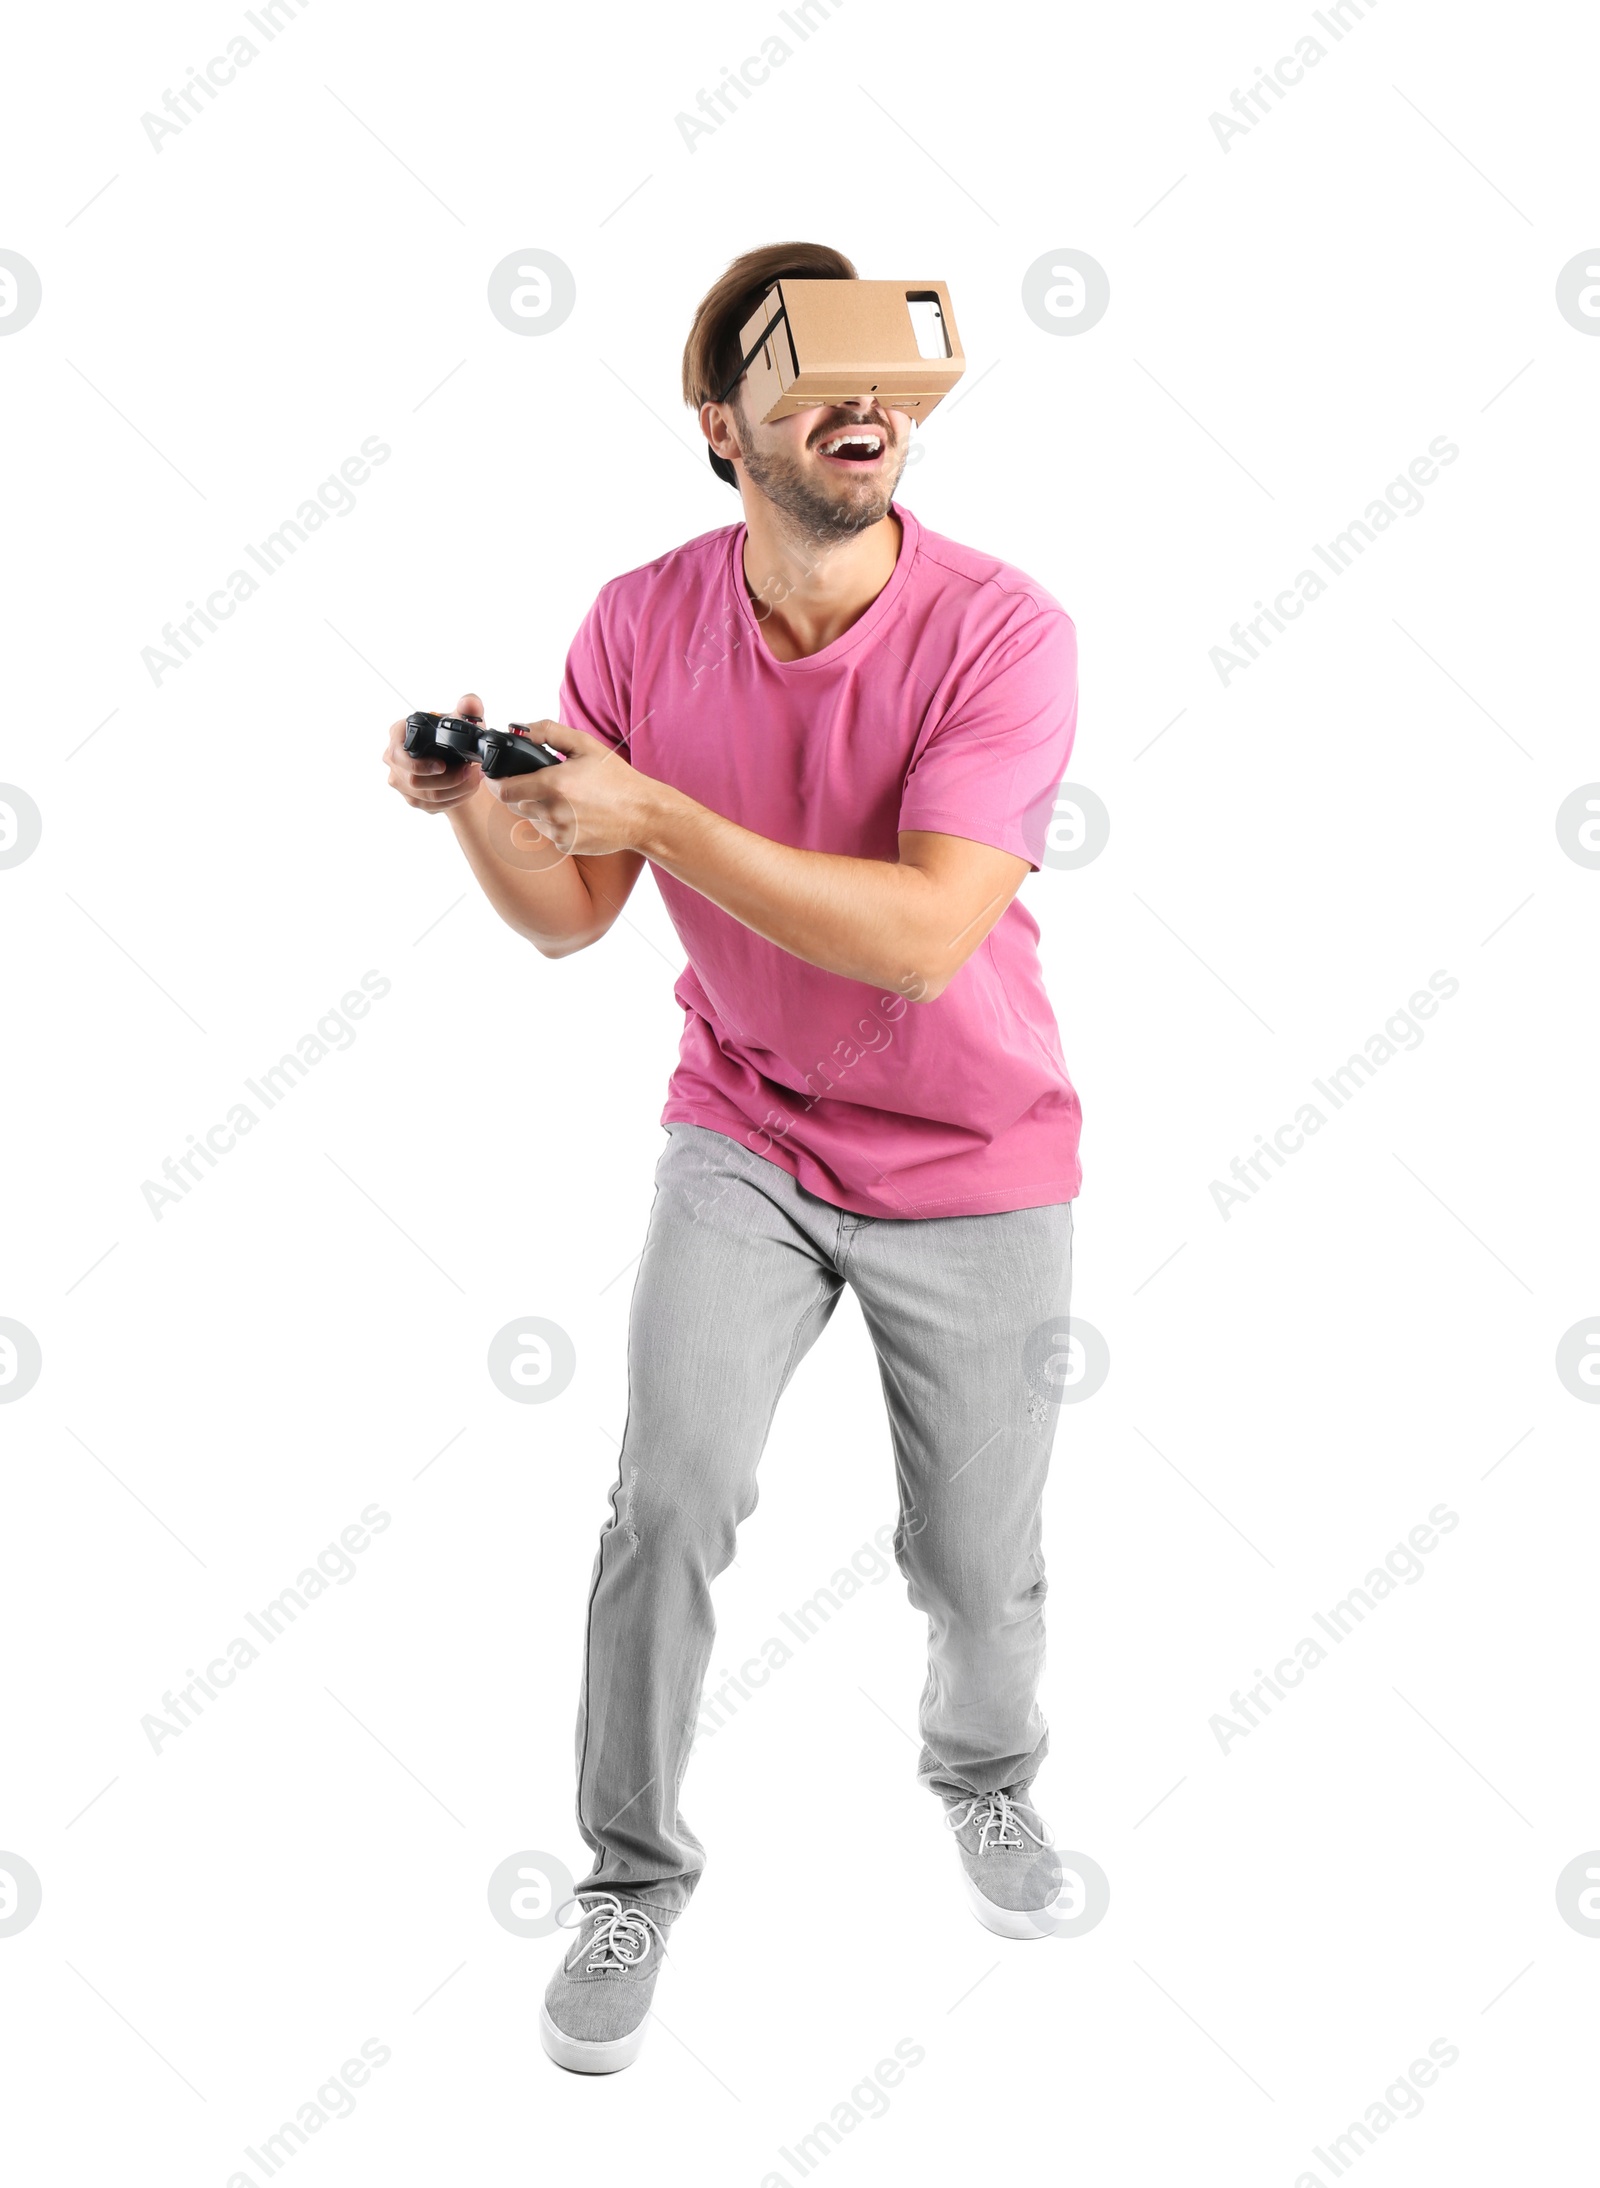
[578,1125,1073,1915]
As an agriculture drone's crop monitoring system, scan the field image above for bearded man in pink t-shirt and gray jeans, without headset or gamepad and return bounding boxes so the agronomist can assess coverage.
[385,245,1079,2072]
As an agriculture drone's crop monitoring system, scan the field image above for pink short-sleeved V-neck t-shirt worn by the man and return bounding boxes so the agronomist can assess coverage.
[560,503,1081,1217]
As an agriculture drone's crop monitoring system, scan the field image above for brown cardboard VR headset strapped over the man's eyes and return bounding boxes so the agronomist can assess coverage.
[718,280,967,424]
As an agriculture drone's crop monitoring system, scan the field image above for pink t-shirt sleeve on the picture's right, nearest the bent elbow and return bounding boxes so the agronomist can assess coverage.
[900,608,1077,873]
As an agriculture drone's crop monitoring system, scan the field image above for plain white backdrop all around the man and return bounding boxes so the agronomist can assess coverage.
[0,0,1600,2188]
